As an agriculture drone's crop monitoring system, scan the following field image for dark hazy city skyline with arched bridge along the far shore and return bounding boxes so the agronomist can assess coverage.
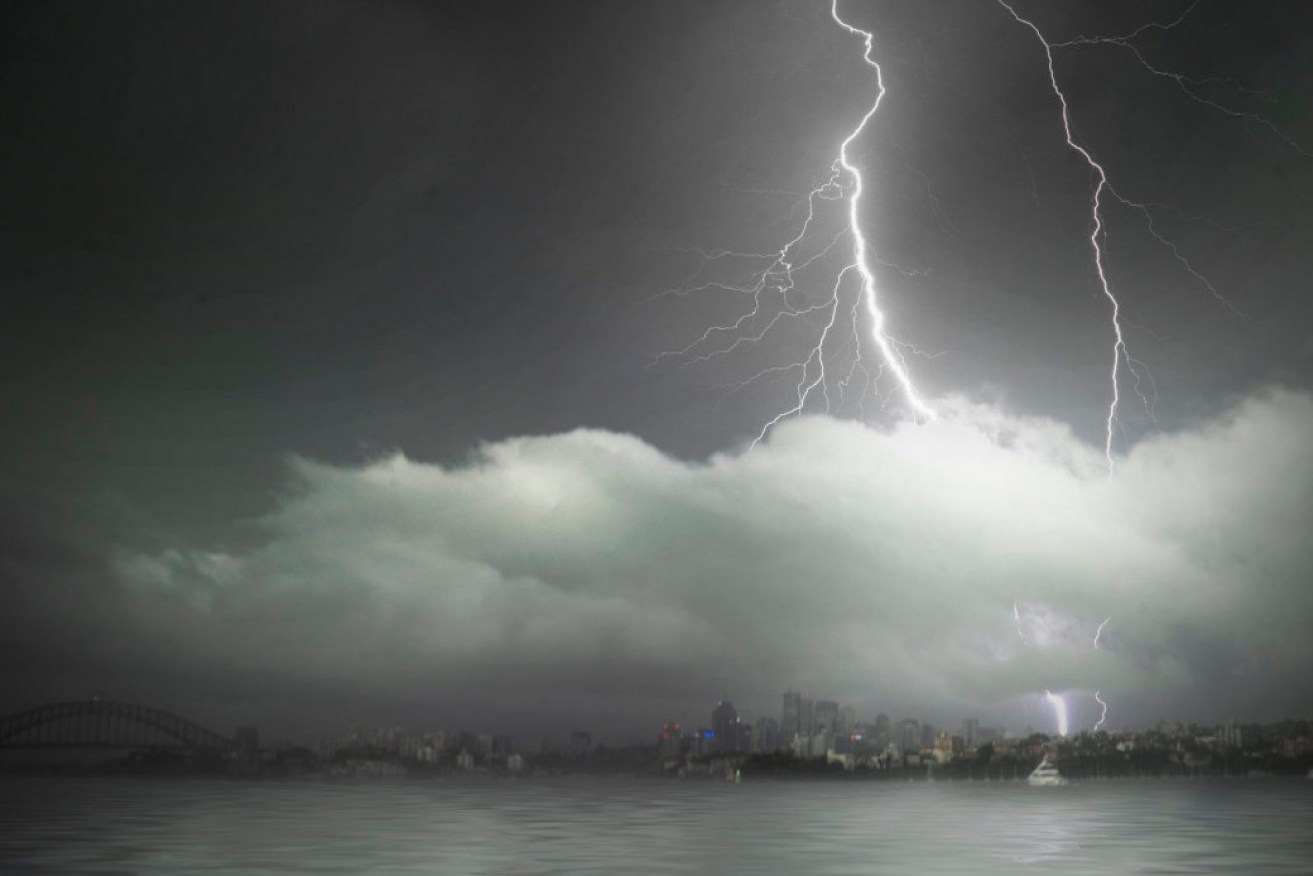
[0,690,1281,760]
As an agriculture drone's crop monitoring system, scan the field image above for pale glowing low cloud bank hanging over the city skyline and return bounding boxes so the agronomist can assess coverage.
[114,390,1313,726]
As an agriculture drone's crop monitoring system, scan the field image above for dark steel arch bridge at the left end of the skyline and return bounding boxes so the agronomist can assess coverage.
[0,697,234,753]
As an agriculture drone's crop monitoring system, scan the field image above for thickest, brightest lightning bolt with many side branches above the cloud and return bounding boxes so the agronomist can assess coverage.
[654,0,935,447]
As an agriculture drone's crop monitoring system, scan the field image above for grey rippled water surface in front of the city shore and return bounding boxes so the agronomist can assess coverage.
[0,777,1313,876]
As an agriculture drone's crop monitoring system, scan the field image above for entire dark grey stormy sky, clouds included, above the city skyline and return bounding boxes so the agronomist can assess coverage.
[0,0,1313,739]
